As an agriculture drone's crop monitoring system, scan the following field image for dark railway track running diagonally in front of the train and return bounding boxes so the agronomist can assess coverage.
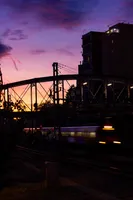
[16,146,133,178]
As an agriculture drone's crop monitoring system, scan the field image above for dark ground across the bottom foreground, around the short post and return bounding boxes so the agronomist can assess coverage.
[0,146,133,200]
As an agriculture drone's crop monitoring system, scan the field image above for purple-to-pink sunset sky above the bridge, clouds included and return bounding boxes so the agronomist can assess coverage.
[0,0,133,83]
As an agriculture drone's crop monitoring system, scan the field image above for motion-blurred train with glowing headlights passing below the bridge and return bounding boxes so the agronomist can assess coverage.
[24,118,122,145]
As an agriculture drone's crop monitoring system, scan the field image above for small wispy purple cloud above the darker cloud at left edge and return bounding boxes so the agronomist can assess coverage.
[2,29,28,40]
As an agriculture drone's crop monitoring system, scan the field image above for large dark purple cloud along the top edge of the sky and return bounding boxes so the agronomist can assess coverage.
[1,0,99,29]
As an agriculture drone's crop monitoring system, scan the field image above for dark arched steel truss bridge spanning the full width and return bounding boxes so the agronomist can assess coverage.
[0,74,133,111]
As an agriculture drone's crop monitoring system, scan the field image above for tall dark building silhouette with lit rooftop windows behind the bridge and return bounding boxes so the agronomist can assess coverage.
[79,23,133,78]
